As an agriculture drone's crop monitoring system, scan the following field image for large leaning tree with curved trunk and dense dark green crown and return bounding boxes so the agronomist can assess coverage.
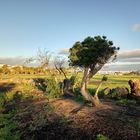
[69,36,119,106]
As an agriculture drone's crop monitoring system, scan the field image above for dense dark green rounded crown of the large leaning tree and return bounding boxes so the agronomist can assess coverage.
[69,36,119,67]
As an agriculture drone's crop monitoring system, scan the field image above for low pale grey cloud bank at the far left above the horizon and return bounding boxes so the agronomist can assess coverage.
[0,56,26,65]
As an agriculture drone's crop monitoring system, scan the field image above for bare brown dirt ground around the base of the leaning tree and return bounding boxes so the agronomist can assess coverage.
[15,98,140,140]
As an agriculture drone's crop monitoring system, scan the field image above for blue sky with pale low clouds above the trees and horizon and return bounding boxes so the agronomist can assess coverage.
[0,0,140,70]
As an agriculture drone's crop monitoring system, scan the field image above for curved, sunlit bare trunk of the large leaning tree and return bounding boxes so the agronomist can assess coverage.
[81,68,100,106]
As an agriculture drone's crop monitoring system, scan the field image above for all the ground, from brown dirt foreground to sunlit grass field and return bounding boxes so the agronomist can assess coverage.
[0,73,140,140]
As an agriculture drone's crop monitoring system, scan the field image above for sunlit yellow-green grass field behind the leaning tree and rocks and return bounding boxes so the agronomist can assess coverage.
[0,73,140,88]
